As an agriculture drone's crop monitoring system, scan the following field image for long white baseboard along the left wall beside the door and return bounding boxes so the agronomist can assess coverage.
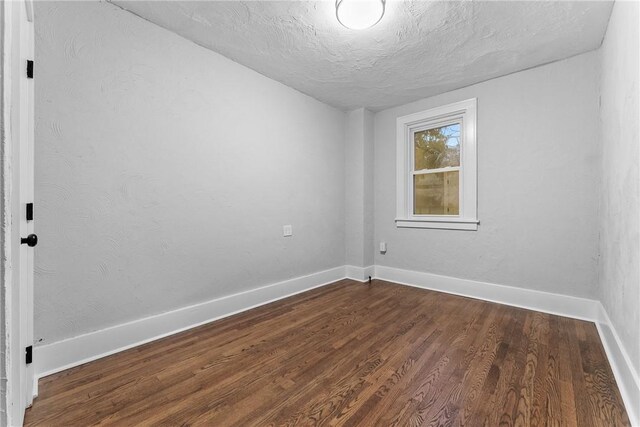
[33,266,345,382]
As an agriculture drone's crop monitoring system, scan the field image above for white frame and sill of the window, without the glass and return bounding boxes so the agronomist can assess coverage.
[396,98,479,230]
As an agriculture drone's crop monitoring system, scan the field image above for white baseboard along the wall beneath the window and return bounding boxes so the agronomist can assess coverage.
[375,265,600,322]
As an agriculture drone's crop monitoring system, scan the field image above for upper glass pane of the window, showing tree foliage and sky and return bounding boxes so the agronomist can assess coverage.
[414,123,460,171]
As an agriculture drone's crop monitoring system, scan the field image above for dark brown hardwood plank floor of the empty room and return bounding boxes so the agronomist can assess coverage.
[26,280,629,426]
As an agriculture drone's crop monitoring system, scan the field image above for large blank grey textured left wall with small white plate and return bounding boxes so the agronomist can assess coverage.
[35,2,345,343]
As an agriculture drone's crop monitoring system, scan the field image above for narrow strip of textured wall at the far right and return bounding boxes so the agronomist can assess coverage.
[599,1,640,372]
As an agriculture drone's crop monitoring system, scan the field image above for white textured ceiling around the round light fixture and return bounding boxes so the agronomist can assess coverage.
[111,0,612,110]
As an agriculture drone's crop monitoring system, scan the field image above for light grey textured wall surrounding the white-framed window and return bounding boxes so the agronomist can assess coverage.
[375,53,599,298]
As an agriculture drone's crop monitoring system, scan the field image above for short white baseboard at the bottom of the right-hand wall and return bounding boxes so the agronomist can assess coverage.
[596,303,640,427]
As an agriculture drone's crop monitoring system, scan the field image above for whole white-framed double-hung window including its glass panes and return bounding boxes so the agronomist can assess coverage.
[396,99,478,230]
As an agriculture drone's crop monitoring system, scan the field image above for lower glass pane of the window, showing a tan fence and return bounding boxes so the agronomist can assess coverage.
[413,171,460,215]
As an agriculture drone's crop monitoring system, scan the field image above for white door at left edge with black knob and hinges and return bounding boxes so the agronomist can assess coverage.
[0,0,35,426]
